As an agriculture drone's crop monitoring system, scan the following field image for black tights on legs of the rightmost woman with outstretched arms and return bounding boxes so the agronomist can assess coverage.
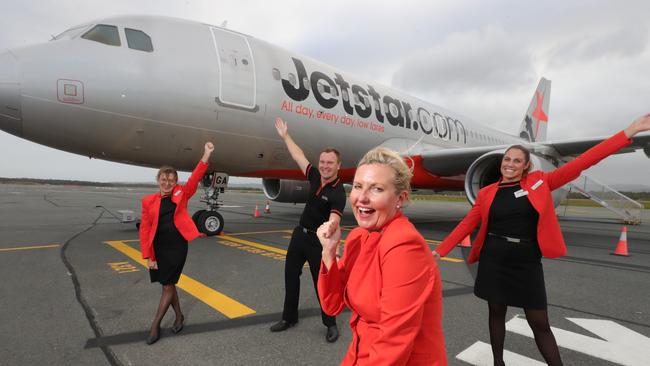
[488,302,562,366]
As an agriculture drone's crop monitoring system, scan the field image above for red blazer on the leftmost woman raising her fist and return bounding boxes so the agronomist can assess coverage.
[140,161,208,261]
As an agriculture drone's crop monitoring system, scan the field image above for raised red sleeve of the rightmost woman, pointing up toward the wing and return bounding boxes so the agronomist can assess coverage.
[546,131,632,190]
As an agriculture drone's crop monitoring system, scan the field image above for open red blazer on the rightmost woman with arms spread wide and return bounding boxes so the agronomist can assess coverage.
[436,131,632,263]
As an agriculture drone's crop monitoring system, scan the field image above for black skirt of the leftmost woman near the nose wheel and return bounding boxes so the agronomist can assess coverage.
[149,232,187,285]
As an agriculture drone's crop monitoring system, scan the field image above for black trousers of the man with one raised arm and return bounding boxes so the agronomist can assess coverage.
[282,226,336,327]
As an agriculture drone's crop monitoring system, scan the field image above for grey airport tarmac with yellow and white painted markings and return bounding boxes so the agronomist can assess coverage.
[0,184,650,365]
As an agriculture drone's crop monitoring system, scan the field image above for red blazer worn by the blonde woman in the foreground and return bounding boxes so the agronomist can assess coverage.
[318,214,447,366]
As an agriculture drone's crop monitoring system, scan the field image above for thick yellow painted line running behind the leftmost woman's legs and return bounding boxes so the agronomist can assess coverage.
[105,240,255,319]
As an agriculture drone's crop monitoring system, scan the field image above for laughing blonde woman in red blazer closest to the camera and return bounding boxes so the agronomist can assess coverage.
[317,148,447,366]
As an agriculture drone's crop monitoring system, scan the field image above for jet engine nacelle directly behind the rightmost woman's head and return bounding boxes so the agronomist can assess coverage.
[465,149,568,207]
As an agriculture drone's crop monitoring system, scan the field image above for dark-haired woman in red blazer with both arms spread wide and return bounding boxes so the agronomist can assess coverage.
[434,114,650,365]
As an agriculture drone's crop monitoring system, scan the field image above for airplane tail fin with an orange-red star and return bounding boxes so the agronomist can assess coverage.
[519,78,551,142]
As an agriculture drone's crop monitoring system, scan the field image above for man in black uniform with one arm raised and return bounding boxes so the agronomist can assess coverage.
[271,118,345,343]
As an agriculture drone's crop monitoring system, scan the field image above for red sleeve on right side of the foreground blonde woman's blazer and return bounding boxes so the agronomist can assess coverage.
[368,228,434,365]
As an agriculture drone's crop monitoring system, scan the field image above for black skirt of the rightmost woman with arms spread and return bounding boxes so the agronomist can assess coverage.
[474,235,546,309]
